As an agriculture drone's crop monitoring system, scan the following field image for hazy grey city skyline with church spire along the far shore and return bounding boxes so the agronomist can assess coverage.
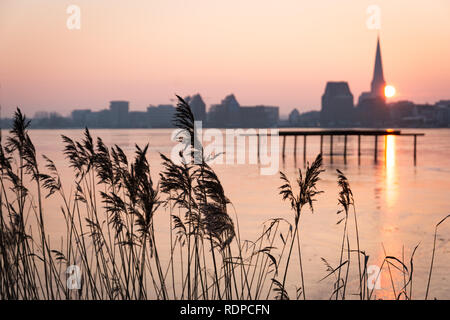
[0,35,450,129]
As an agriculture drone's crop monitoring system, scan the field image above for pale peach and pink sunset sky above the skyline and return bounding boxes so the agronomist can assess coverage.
[0,0,450,116]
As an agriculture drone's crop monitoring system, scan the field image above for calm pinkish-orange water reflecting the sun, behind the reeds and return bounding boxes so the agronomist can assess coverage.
[30,129,450,299]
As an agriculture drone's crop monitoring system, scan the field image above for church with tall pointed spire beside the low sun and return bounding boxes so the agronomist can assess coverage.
[357,37,389,126]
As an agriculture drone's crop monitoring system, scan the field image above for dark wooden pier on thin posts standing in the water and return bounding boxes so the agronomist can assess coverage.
[279,129,425,165]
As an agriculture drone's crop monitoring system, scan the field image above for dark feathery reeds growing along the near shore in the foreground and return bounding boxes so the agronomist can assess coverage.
[0,97,446,300]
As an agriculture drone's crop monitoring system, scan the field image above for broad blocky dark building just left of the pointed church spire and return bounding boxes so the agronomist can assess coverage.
[320,81,354,127]
